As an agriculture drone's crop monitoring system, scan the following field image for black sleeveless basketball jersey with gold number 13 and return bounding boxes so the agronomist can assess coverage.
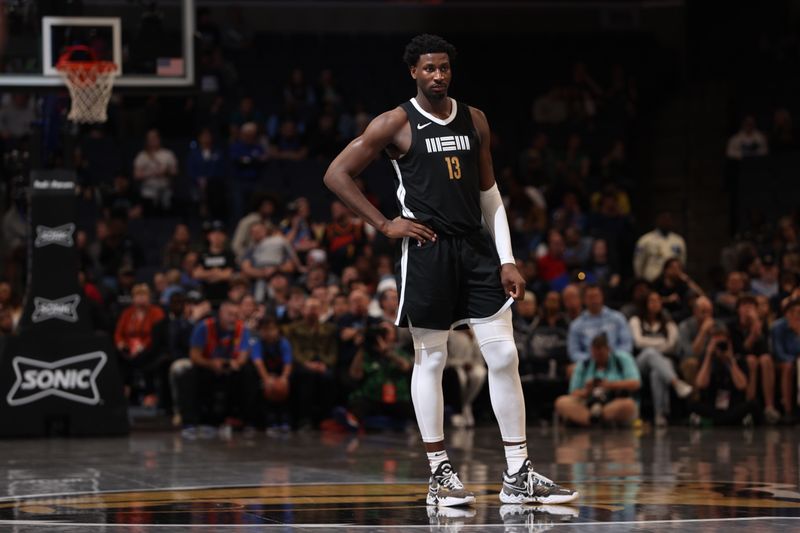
[391,98,481,235]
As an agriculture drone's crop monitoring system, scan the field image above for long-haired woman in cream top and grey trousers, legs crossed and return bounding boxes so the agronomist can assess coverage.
[629,292,692,427]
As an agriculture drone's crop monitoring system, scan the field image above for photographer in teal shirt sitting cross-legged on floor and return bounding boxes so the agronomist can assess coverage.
[556,333,641,426]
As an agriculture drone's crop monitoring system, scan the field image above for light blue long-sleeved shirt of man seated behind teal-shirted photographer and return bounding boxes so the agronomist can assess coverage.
[567,306,633,363]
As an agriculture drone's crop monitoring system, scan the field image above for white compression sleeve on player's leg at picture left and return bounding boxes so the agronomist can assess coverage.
[411,326,449,442]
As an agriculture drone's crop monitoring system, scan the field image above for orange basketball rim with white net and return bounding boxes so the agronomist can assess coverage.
[56,46,118,123]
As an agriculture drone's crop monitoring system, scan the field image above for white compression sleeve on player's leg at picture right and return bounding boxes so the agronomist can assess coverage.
[471,309,525,442]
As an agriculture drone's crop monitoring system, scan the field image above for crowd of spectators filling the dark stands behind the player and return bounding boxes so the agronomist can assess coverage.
[0,20,800,436]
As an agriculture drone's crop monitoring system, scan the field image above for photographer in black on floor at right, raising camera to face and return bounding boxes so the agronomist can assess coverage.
[689,326,755,425]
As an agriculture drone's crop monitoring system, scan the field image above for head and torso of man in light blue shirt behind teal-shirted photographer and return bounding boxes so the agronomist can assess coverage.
[567,285,633,363]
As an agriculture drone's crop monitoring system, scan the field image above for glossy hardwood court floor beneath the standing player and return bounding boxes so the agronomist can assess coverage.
[0,427,800,533]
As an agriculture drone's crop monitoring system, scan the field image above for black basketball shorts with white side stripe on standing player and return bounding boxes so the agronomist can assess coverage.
[395,230,513,330]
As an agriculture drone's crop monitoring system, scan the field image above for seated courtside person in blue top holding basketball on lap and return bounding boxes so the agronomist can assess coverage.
[253,317,293,431]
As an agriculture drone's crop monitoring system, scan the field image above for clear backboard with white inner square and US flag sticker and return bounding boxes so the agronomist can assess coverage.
[0,0,195,87]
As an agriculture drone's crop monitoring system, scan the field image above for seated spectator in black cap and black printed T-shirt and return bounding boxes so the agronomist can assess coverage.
[192,220,236,306]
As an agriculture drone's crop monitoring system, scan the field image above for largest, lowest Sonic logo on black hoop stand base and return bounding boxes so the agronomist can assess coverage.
[6,352,108,407]
